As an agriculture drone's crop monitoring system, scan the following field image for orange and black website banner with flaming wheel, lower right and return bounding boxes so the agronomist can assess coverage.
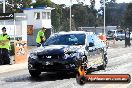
[76,74,131,85]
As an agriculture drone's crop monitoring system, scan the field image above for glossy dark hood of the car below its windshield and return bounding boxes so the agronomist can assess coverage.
[37,45,82,55]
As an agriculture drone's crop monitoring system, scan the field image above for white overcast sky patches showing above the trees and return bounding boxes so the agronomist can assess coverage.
[51,0,132,9]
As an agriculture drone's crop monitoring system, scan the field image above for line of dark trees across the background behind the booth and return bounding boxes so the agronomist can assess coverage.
[0,0,132,32]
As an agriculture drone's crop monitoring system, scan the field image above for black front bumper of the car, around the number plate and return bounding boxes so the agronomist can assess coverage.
[28,57,81,72]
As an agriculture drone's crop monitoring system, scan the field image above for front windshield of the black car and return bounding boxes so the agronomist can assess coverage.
[45,34,85,46]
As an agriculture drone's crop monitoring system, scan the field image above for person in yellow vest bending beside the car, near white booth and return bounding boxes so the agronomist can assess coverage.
[36,27,46,47]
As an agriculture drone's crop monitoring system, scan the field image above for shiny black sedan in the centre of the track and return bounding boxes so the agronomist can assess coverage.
[28,31,108,77]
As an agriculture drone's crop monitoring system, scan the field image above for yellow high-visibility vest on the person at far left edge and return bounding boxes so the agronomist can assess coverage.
[0,34,10,50]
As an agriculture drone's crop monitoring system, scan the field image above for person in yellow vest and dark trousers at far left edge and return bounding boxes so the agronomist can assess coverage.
[0,27,10,65]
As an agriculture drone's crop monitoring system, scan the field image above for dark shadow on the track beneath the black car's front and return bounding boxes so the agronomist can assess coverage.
[4,73,75,82]
